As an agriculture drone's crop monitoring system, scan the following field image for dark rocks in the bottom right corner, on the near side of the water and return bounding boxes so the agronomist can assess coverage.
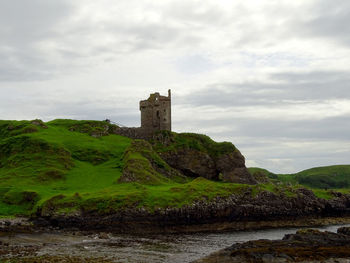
[195,228,350,263]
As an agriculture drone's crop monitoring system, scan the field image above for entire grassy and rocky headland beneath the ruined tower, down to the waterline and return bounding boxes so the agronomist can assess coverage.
[0,120,350,232]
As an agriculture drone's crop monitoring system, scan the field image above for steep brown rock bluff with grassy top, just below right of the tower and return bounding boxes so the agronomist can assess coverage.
[153,133,257,184]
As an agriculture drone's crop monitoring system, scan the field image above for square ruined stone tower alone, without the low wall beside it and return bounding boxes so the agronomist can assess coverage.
[140,90,171,132]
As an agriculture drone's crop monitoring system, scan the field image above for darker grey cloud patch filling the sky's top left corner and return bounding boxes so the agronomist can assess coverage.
[0,0,72,81]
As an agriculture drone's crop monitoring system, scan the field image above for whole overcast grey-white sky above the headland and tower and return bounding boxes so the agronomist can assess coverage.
[0,0,350,173]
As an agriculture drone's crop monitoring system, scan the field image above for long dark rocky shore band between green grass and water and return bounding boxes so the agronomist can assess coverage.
[35,189,350,232]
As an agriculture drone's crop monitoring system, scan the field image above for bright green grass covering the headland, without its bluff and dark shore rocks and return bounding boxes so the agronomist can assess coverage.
[0,120,254,219]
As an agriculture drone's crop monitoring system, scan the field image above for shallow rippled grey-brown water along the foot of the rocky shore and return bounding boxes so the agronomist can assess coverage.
[0,224,350,263]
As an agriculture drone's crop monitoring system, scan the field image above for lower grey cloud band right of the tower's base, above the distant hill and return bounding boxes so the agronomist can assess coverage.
[174,113,350,141]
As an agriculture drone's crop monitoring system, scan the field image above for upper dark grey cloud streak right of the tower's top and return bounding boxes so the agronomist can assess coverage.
[176,71,350,108]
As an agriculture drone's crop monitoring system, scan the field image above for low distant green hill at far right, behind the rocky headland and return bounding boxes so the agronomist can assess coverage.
[248,165,350,189]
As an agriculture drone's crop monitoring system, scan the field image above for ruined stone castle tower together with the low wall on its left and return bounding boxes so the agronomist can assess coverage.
[116,89,171,139]
